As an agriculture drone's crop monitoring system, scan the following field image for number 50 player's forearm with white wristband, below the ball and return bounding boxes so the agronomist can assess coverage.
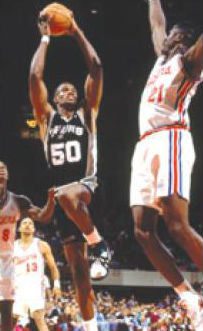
[30,36,49,79]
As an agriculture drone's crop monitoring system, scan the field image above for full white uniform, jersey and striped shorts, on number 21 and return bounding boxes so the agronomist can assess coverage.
[130,54,201,208]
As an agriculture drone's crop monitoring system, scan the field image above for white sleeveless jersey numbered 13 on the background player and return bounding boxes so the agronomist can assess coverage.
[14,238,44,291]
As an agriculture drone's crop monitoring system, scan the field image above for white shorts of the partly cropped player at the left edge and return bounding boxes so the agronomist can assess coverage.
[0,254,14,301]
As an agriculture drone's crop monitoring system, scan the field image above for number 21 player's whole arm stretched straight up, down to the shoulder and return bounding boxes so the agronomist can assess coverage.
[148,0,166,56]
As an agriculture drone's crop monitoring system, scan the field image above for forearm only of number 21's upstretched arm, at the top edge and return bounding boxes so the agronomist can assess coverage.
[148,0,166,31]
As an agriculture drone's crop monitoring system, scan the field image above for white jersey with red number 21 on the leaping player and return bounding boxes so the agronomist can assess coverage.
[139,54,201,136]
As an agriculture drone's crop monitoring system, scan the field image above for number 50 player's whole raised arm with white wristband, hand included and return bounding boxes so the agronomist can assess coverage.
[29,22,52,138]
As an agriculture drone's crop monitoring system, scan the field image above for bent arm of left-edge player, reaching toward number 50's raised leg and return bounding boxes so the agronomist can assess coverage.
[16,189,55,224]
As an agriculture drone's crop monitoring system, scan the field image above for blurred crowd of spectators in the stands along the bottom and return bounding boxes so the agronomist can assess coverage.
[15,285,203,331]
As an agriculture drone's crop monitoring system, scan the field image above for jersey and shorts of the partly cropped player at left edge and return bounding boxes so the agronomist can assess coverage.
[0,192,20,301]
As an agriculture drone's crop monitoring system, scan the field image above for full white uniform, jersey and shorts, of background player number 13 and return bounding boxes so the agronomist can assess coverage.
[13,238,45,316]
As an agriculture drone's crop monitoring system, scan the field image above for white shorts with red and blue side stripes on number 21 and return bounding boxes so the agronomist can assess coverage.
[130,128,195,209]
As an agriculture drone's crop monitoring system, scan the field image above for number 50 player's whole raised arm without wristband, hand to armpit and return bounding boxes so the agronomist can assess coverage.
[73,20,103,115]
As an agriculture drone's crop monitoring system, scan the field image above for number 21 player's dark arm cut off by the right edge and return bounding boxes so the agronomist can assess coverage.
[184,34,203,79]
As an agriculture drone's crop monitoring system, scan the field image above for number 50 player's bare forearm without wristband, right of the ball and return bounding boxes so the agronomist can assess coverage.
[74,28,102,77]
